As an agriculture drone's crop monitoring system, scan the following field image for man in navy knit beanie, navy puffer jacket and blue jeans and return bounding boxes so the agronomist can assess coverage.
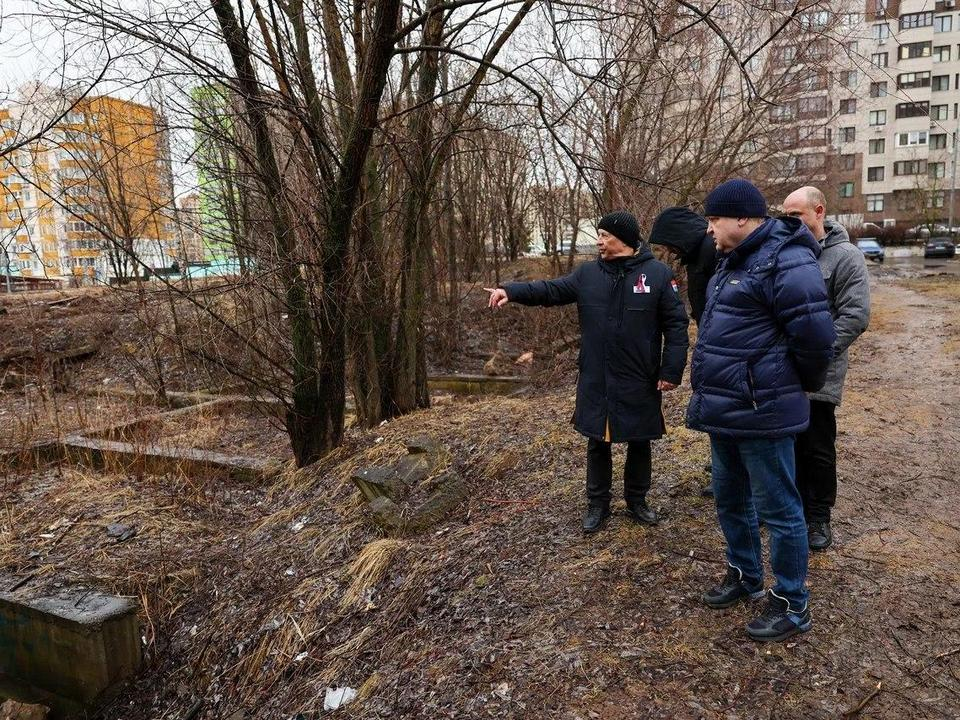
[687,179,835,641]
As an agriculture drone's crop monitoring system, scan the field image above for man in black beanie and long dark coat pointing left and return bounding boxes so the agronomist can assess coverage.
[487,210,688,533]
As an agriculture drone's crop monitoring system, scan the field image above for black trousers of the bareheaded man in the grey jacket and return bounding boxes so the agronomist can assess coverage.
[795,400,837,522]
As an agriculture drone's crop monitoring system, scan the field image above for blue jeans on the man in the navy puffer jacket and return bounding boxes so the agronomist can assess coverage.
[710,435,810,612]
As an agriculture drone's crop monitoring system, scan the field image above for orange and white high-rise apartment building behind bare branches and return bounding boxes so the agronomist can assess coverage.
[0,86,177,282]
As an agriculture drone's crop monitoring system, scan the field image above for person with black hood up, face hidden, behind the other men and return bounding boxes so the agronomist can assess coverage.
[650,207,717,497]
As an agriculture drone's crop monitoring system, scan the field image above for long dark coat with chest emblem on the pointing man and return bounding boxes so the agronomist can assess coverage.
[503,246,688,442]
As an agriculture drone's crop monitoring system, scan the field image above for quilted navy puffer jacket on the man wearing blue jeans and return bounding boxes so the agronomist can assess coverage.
[687,217,835,438]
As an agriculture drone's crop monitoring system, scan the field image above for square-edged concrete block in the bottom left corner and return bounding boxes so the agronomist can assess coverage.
[0,591,142,715]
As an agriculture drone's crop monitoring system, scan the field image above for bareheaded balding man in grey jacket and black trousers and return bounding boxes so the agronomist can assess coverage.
[783,187,870,552]
